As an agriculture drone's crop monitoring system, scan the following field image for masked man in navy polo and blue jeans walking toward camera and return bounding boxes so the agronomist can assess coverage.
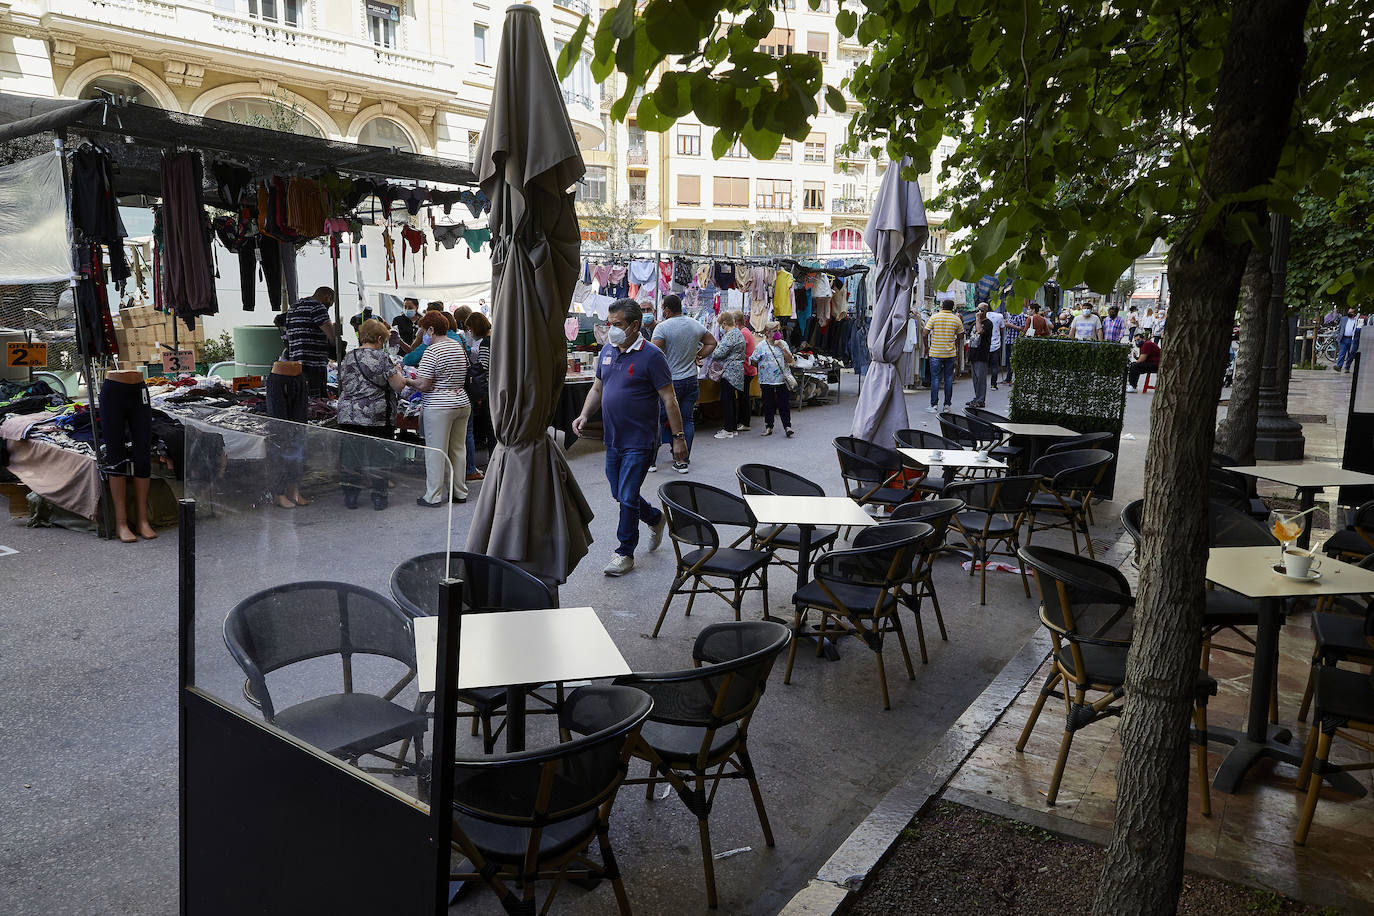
[573,299,687,575]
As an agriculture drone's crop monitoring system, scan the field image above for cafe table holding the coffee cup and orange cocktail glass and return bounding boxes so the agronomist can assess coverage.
[1206,547,1374,797]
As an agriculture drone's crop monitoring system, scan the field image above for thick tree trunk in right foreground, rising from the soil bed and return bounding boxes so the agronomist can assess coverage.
[1094,0,1308,916]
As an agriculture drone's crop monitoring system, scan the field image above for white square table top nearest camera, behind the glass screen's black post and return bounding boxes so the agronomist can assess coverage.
[414,607,629,692]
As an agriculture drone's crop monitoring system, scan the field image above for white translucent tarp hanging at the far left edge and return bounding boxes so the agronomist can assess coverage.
[0,152,71,286]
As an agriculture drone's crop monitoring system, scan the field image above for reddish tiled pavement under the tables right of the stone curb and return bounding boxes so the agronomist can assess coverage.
[949,372,1374,911]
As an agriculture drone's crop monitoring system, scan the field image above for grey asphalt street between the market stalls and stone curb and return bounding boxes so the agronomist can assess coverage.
[0,374,1150,916]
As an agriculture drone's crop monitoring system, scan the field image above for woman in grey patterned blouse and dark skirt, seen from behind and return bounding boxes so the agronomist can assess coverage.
[338,319,405,511]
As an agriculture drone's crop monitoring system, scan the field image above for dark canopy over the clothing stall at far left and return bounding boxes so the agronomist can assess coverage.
[0,93,477,196]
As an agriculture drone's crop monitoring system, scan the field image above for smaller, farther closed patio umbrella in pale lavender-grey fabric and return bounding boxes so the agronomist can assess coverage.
[851,157,930,448]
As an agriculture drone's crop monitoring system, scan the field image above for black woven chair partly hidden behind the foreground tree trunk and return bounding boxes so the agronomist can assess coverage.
[1017,547,1217,814]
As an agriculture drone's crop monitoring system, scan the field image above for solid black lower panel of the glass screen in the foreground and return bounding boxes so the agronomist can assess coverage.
[181,689,436,916]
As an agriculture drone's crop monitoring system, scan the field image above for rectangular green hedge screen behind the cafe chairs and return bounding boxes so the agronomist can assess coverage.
[1011,336,1131,433]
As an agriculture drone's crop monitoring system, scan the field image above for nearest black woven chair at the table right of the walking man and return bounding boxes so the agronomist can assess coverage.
[783,522,933,709]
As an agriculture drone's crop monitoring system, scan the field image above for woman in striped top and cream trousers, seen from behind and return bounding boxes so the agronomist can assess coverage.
[415,312,473,508]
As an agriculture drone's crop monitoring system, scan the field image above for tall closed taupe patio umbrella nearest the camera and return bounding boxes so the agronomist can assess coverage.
[455,5,592,582]
